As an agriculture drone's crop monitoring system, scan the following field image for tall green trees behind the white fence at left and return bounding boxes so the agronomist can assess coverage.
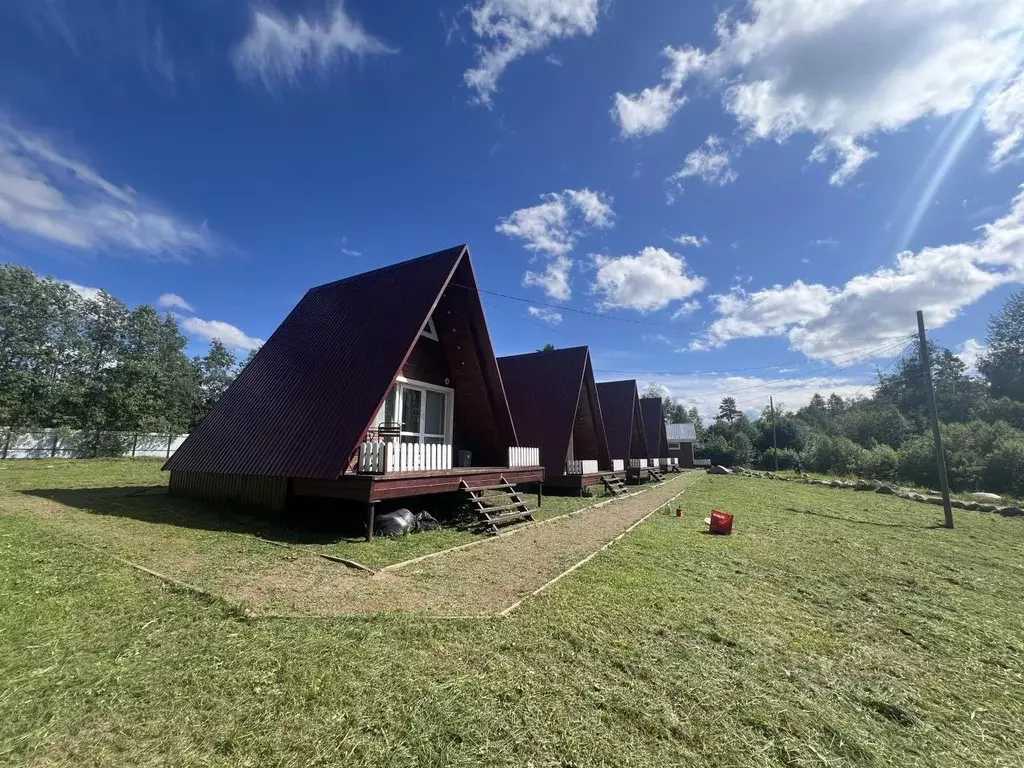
[0,264,249,433]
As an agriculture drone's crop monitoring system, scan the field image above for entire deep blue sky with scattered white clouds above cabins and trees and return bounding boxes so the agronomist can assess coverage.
[0,0,1024,410]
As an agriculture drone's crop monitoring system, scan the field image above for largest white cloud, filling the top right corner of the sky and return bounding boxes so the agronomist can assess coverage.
[622,0,1024,185]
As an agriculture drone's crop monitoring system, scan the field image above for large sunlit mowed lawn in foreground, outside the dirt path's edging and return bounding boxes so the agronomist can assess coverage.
[0,460,1024,767]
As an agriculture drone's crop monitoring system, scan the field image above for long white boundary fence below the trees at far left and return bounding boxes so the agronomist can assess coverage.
[0,427,188,459]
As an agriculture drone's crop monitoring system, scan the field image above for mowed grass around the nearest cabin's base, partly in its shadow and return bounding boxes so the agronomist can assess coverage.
[0,459,601,584]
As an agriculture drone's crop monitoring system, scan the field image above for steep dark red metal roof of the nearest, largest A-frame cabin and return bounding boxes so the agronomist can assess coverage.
[164,245,517,479]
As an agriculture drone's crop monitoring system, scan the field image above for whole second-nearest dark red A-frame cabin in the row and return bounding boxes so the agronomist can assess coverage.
[498,347,611,488]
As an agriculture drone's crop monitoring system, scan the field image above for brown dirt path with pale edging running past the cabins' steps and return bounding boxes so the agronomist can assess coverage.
[250,472,700,615]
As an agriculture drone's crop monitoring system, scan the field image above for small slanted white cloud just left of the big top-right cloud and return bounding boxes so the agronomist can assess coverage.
[611,46,707,138]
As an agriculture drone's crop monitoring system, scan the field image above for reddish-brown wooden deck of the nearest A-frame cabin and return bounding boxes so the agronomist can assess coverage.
[291,467,544,504]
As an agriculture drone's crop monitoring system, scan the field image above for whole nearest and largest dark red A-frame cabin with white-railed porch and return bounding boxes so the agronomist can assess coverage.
[164,245,544,535]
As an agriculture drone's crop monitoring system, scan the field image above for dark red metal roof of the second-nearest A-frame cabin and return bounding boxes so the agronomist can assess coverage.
[498,347,610,477]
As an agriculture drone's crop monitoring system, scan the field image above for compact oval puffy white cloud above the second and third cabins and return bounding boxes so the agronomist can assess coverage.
[590,247,706,312]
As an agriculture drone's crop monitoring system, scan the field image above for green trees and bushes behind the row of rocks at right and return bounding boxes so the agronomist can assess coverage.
[651,292,1024,498]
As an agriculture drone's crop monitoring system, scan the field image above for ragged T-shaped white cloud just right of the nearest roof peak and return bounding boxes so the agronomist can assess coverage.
[495,189,615,301]
